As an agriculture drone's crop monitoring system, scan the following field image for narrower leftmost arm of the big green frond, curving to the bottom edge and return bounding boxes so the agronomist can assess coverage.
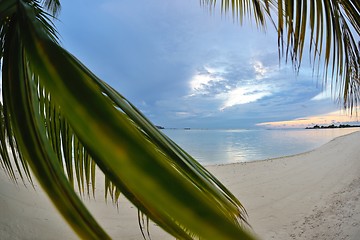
[2,6,109,239]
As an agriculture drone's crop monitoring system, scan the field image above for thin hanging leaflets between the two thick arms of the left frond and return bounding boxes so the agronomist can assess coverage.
[34,78,95,194]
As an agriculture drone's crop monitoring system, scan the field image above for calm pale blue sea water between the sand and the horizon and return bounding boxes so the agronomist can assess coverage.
[162,128,359,165]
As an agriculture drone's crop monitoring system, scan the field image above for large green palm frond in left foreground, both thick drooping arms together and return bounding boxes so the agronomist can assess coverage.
[3,1,251,239]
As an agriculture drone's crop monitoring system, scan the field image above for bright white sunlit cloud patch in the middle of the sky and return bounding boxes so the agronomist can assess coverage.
[187,60,276,111]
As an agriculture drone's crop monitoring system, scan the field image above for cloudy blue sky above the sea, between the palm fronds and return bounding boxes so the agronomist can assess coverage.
[56,0,356,128]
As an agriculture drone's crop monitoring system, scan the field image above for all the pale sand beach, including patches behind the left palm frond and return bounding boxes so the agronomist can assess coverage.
[0,132,360,240]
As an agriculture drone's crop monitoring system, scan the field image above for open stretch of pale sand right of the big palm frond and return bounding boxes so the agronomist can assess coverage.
[207,131,360,240]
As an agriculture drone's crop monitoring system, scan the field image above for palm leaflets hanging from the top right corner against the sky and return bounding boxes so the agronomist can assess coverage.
[208,0,360,110]
